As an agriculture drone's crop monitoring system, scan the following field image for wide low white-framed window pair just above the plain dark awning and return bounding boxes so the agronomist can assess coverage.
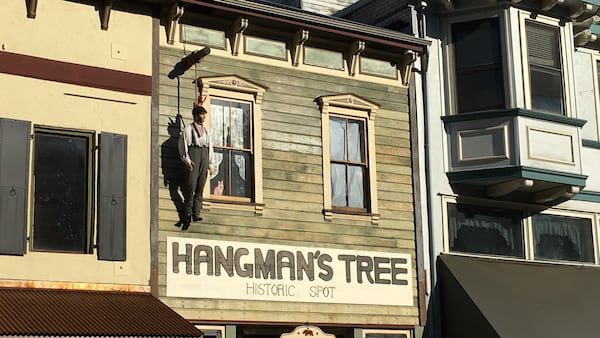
[444,198,600,264]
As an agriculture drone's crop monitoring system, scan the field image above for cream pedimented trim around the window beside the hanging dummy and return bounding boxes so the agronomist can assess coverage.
[198,76,266,216]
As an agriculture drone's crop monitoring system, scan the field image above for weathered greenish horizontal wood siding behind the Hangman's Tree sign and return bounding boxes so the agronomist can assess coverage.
[158,48,418,325]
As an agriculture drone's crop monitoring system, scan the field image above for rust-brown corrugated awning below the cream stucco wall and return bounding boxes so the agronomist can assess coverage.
[0,288,202,337]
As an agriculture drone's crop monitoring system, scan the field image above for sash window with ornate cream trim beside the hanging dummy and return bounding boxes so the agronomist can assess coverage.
[200,76,265,215]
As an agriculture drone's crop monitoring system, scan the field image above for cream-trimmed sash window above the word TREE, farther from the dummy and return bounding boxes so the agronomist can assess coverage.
[318,95,379,222]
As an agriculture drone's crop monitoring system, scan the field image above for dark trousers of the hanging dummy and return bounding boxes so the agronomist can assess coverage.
[183,147,208,216]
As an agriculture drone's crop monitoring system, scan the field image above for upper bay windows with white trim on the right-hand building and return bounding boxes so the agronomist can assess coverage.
[447,9,574,116]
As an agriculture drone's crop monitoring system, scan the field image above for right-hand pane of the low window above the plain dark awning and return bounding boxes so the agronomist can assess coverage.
[532,214,594,262]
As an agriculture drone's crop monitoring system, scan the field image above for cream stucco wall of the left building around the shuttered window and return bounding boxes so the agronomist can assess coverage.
[0,0,152,286]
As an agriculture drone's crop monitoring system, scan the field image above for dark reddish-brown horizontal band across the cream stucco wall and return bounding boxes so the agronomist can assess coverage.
[0,51,152,96]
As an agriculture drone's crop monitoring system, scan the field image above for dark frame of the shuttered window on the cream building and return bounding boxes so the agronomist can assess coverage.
[29,125,97,254]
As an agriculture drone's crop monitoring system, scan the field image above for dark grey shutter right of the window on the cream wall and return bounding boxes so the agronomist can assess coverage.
[97,133,127,261]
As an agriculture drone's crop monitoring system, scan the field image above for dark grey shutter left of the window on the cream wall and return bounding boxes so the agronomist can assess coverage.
[0,119,31,255]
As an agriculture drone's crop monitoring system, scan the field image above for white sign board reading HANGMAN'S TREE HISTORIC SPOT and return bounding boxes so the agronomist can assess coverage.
[167,237,413,306]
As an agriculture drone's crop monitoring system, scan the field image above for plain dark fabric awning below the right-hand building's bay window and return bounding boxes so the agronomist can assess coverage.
[438,255,600,338]
